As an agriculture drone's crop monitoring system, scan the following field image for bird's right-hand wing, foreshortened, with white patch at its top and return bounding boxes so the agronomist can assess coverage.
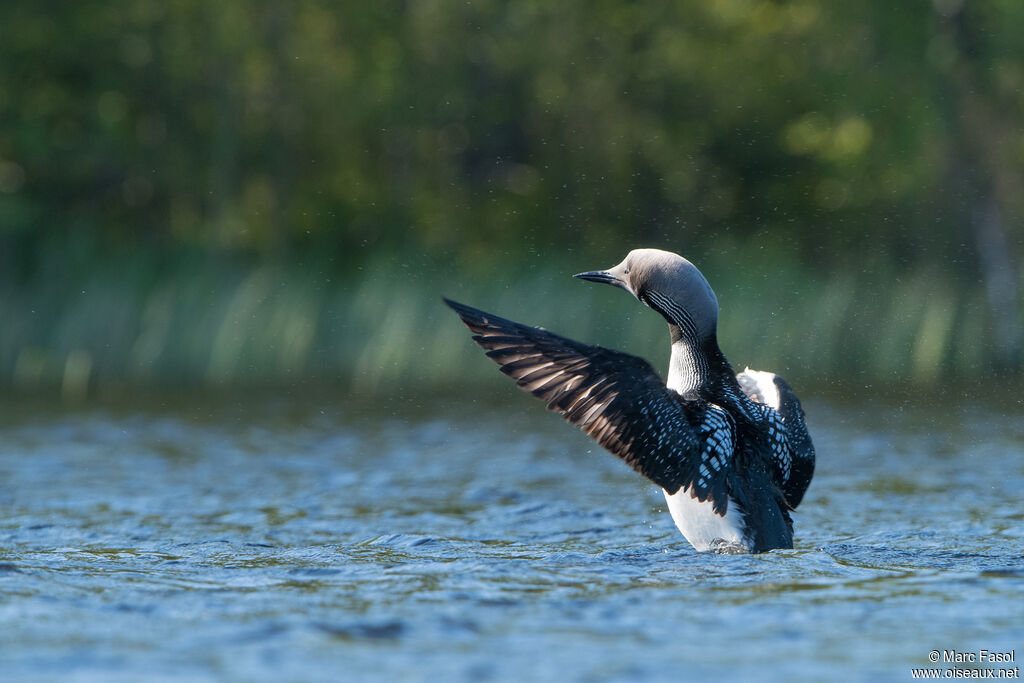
[736,368,814,510]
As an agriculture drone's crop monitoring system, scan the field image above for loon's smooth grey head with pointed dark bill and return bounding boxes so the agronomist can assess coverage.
[573,249,718,341]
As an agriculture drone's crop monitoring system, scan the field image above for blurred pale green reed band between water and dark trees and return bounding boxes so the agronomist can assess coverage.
[0,248,1007,399]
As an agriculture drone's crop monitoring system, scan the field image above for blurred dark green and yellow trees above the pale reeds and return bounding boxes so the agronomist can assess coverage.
[0,0,1024,288]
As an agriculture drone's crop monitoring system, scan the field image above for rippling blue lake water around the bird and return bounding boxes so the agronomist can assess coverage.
[0,391,1024,682]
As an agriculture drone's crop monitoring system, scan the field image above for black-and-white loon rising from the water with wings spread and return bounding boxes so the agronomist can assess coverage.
[443,249,815,554]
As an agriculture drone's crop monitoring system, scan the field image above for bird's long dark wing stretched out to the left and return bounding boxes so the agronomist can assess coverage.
[444,299,735,515]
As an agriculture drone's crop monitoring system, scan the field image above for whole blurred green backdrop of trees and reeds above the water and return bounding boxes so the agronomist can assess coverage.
[0,0,1024,399]
